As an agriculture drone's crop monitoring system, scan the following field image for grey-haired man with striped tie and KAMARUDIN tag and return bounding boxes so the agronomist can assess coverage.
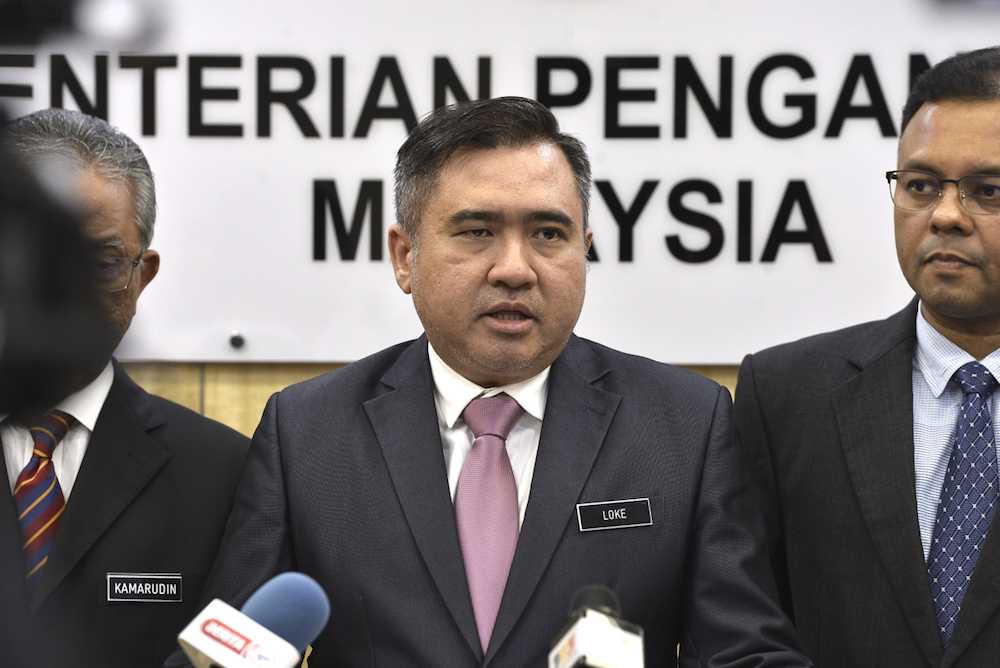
[0,109,249,668]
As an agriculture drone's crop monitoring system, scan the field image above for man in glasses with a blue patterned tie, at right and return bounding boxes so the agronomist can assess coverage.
[735,48,1000,668]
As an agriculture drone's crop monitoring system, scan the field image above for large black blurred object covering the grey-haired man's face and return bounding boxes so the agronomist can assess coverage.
[0,140,112,413]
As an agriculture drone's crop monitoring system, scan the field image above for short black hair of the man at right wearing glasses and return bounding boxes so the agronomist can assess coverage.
[899,46,1000,135]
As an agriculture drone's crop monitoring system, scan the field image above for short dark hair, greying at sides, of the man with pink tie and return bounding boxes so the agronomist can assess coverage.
[395,97,591,239]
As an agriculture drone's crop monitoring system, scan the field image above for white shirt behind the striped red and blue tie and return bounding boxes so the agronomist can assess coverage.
[0,362,115,501]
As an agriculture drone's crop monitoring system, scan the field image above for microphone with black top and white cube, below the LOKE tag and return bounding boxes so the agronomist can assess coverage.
[549,585,643,668]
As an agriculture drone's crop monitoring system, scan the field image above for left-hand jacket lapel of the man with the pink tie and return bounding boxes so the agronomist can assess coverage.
[365,337,482,657]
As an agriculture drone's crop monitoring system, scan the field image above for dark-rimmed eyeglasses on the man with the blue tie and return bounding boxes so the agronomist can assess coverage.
[885,170,1000,216]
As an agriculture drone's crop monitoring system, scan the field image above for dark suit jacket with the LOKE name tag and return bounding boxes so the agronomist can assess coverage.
[178,337,806,668]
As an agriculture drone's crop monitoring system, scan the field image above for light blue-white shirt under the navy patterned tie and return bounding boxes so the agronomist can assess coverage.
[913,308,1000,561]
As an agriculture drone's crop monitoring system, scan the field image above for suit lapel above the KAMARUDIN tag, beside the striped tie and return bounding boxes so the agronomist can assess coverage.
[31,364,170,611]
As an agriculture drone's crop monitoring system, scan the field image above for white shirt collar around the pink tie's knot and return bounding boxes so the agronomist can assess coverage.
[427,341,551,429]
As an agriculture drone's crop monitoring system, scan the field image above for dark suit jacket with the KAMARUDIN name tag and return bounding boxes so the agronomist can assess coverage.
[0,363,249,668]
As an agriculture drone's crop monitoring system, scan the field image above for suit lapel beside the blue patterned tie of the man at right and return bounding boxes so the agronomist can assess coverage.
[832,302,943,666]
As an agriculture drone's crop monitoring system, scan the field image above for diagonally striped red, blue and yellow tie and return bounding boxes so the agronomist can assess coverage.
[14,411,76,593]
